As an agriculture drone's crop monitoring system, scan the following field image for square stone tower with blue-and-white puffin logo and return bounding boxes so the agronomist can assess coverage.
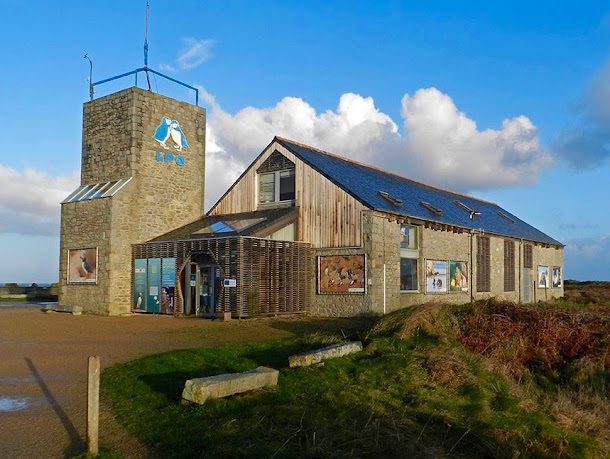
[59,87,205,315]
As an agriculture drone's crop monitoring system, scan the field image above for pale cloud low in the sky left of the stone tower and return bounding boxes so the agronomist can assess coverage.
[0,164,79,236]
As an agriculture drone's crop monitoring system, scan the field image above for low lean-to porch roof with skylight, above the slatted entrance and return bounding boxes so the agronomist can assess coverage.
[149,207,298,242]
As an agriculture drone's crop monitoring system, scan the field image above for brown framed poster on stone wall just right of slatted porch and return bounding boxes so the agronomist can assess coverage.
[318,254,366,293]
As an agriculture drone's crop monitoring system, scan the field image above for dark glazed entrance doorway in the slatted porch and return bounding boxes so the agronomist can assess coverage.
[184,254,221,317]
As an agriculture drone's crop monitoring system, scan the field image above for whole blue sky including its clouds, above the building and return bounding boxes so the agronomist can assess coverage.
[0,0,610,282]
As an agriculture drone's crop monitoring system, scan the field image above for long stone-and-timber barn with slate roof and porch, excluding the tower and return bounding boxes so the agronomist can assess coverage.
[133,137,563,317]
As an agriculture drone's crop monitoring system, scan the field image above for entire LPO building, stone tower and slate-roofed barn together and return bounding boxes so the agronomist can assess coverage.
[59,88,563,318]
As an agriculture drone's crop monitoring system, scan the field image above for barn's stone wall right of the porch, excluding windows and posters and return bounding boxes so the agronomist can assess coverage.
[310,211,563,316]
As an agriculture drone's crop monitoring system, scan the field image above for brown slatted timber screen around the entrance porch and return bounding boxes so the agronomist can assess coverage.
[132,237,311,318]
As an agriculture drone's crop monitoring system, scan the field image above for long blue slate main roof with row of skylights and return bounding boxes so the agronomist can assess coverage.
[274,137,563,246]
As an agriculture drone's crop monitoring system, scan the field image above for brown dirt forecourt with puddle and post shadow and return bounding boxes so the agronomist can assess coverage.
[0,305,360,458]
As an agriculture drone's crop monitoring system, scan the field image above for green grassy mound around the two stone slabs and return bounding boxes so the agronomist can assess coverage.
[102,304,604,458]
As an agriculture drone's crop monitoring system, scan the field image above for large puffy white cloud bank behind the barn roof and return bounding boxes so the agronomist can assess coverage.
[203,88,552,208]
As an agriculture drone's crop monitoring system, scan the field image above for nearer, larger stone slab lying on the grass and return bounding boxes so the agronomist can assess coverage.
[182,367,279,405]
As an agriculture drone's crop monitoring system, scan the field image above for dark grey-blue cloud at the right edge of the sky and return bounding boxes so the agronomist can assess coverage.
[553,62,610,169]
